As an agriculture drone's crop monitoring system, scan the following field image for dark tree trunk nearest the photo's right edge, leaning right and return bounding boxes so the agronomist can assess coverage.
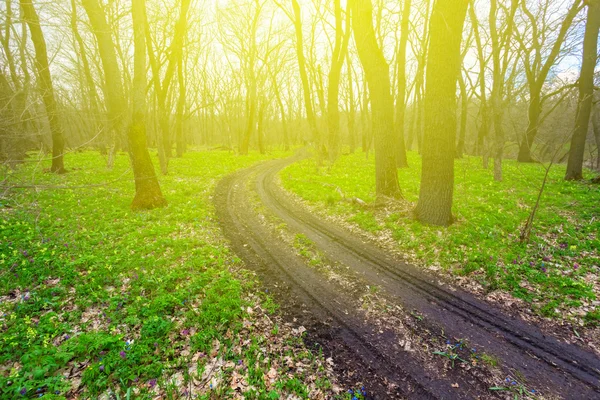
[565,0,600,180]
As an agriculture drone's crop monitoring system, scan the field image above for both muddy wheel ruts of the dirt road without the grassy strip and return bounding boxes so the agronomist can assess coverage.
[215,157,600,399]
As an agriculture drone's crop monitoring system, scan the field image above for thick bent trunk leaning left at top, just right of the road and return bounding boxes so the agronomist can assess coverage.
[352,0,402,198]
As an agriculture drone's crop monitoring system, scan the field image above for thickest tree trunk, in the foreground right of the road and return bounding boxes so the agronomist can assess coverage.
[415,0,468,226]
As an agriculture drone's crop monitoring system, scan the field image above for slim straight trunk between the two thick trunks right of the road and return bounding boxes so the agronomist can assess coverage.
[395,0,411,168]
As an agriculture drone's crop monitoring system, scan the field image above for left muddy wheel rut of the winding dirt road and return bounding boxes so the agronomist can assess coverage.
[214,165,487,399]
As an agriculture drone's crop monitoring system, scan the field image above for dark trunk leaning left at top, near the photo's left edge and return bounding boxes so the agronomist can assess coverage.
[20,0,66,174]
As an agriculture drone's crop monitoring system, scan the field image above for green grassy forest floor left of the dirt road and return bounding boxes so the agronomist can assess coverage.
[0,151,349,399]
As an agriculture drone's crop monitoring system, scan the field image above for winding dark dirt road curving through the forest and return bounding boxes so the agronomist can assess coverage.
[214,157,600,399]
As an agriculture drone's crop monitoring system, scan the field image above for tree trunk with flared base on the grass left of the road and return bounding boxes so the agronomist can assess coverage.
[128,0,167,210]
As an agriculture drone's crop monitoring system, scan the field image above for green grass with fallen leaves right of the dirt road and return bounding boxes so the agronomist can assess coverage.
[282,153,600,324]
